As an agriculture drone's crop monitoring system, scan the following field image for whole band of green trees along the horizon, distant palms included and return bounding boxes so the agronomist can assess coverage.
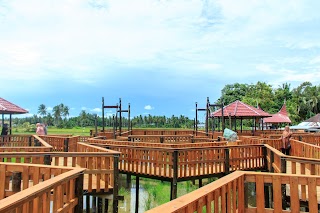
[13,81,320,128]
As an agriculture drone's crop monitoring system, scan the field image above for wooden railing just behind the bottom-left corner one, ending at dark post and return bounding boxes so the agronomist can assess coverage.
[0,143,120,195]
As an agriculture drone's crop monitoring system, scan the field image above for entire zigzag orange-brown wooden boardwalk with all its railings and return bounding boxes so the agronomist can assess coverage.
[0,130,320,212]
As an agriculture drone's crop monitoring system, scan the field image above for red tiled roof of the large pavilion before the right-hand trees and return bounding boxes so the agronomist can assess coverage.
[211,100,271,118]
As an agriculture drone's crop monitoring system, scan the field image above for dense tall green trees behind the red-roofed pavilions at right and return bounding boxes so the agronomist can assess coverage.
[216,81,320,124]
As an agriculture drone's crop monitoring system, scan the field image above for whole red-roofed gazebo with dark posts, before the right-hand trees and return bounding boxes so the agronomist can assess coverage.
[210,100,271,132]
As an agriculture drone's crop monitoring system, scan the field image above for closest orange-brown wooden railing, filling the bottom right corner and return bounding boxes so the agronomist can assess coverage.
[147,171,320,213]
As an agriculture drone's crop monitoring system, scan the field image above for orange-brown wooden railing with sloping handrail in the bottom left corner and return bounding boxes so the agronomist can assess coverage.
[0,163,84,213]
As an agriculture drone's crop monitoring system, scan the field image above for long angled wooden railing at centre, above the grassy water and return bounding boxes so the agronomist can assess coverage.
[92,143,266,180]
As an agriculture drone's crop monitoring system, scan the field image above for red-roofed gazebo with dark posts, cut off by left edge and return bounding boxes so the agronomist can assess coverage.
[0,97,28,135]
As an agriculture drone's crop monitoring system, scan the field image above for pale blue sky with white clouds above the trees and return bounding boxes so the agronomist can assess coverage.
[0,0,320,118]
